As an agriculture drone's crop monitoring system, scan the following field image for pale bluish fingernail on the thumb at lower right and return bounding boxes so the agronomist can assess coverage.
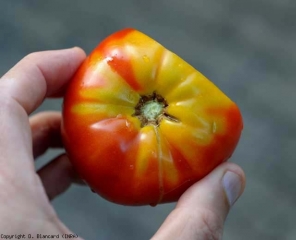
[222,171,242,206]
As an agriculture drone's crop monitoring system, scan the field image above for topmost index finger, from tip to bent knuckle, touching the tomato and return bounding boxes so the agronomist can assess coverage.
[0,48,85,114]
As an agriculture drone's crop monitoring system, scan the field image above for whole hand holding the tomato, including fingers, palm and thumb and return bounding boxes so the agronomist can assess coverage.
[0,47,245,240]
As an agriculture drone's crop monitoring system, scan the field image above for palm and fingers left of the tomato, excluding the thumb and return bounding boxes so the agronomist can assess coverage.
[0,48,85,236]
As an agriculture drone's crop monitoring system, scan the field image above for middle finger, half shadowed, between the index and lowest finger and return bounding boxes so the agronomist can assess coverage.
[30,112,63,158]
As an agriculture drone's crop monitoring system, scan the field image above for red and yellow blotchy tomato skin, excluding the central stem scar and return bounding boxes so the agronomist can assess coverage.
[62,29,243,205]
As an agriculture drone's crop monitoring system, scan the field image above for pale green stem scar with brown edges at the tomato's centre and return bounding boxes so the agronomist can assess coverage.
[133,92,179,127]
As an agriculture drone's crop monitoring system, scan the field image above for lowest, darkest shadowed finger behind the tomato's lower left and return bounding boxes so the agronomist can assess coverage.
[38,154,81,200]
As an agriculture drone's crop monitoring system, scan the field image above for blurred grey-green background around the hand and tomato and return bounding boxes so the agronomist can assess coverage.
[0,0,296,240]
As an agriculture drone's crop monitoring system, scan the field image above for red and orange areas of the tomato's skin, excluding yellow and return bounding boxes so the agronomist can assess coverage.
[62,29,243,206]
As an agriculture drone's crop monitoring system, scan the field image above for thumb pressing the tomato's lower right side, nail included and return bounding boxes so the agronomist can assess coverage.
[152,163,245,240]
